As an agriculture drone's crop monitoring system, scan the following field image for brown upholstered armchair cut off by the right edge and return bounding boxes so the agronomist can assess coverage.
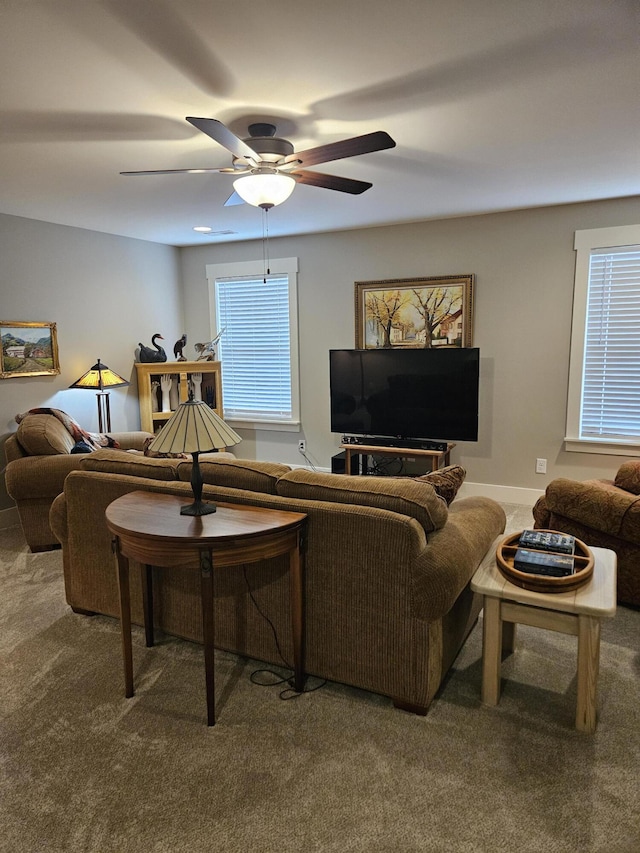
[533,461,640,606]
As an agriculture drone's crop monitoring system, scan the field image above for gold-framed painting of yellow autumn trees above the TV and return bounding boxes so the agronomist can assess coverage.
[355,275,474,349]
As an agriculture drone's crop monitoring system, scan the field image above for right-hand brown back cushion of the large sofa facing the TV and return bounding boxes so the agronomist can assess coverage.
[276,468,448,533]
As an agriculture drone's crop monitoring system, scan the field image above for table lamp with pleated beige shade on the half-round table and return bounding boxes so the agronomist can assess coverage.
[149,400,242,516]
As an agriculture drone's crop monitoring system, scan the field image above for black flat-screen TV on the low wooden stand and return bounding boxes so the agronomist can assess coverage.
[329,347,480,441]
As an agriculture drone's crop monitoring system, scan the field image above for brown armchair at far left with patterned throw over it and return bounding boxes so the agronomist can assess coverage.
[4,414,154,551]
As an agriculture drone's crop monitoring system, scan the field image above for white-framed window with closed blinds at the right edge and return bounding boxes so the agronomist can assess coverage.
[565,225,640,456]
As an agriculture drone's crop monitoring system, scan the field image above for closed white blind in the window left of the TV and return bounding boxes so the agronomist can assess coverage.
[215,275,293,421]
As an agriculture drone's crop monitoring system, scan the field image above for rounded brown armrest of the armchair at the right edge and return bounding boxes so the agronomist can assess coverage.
[545,477,640,544]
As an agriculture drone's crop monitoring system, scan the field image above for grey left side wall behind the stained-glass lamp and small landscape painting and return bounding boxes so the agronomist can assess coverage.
[0,215,183,510]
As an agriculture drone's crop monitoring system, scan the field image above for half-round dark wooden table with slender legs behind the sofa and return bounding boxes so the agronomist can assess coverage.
[106,491,307,726]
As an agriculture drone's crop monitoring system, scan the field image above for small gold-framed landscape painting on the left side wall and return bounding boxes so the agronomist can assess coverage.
[0,320,60,379]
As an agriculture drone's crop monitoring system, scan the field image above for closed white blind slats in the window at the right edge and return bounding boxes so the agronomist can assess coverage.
[580,245,640,441]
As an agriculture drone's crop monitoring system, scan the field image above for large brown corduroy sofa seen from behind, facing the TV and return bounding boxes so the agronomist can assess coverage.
[51,451,505,713]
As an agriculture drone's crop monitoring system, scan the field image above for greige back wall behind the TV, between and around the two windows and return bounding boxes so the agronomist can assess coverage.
[181,193,640,490]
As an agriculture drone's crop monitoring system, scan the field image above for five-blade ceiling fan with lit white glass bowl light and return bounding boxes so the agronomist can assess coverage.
[120,116,396,210]
